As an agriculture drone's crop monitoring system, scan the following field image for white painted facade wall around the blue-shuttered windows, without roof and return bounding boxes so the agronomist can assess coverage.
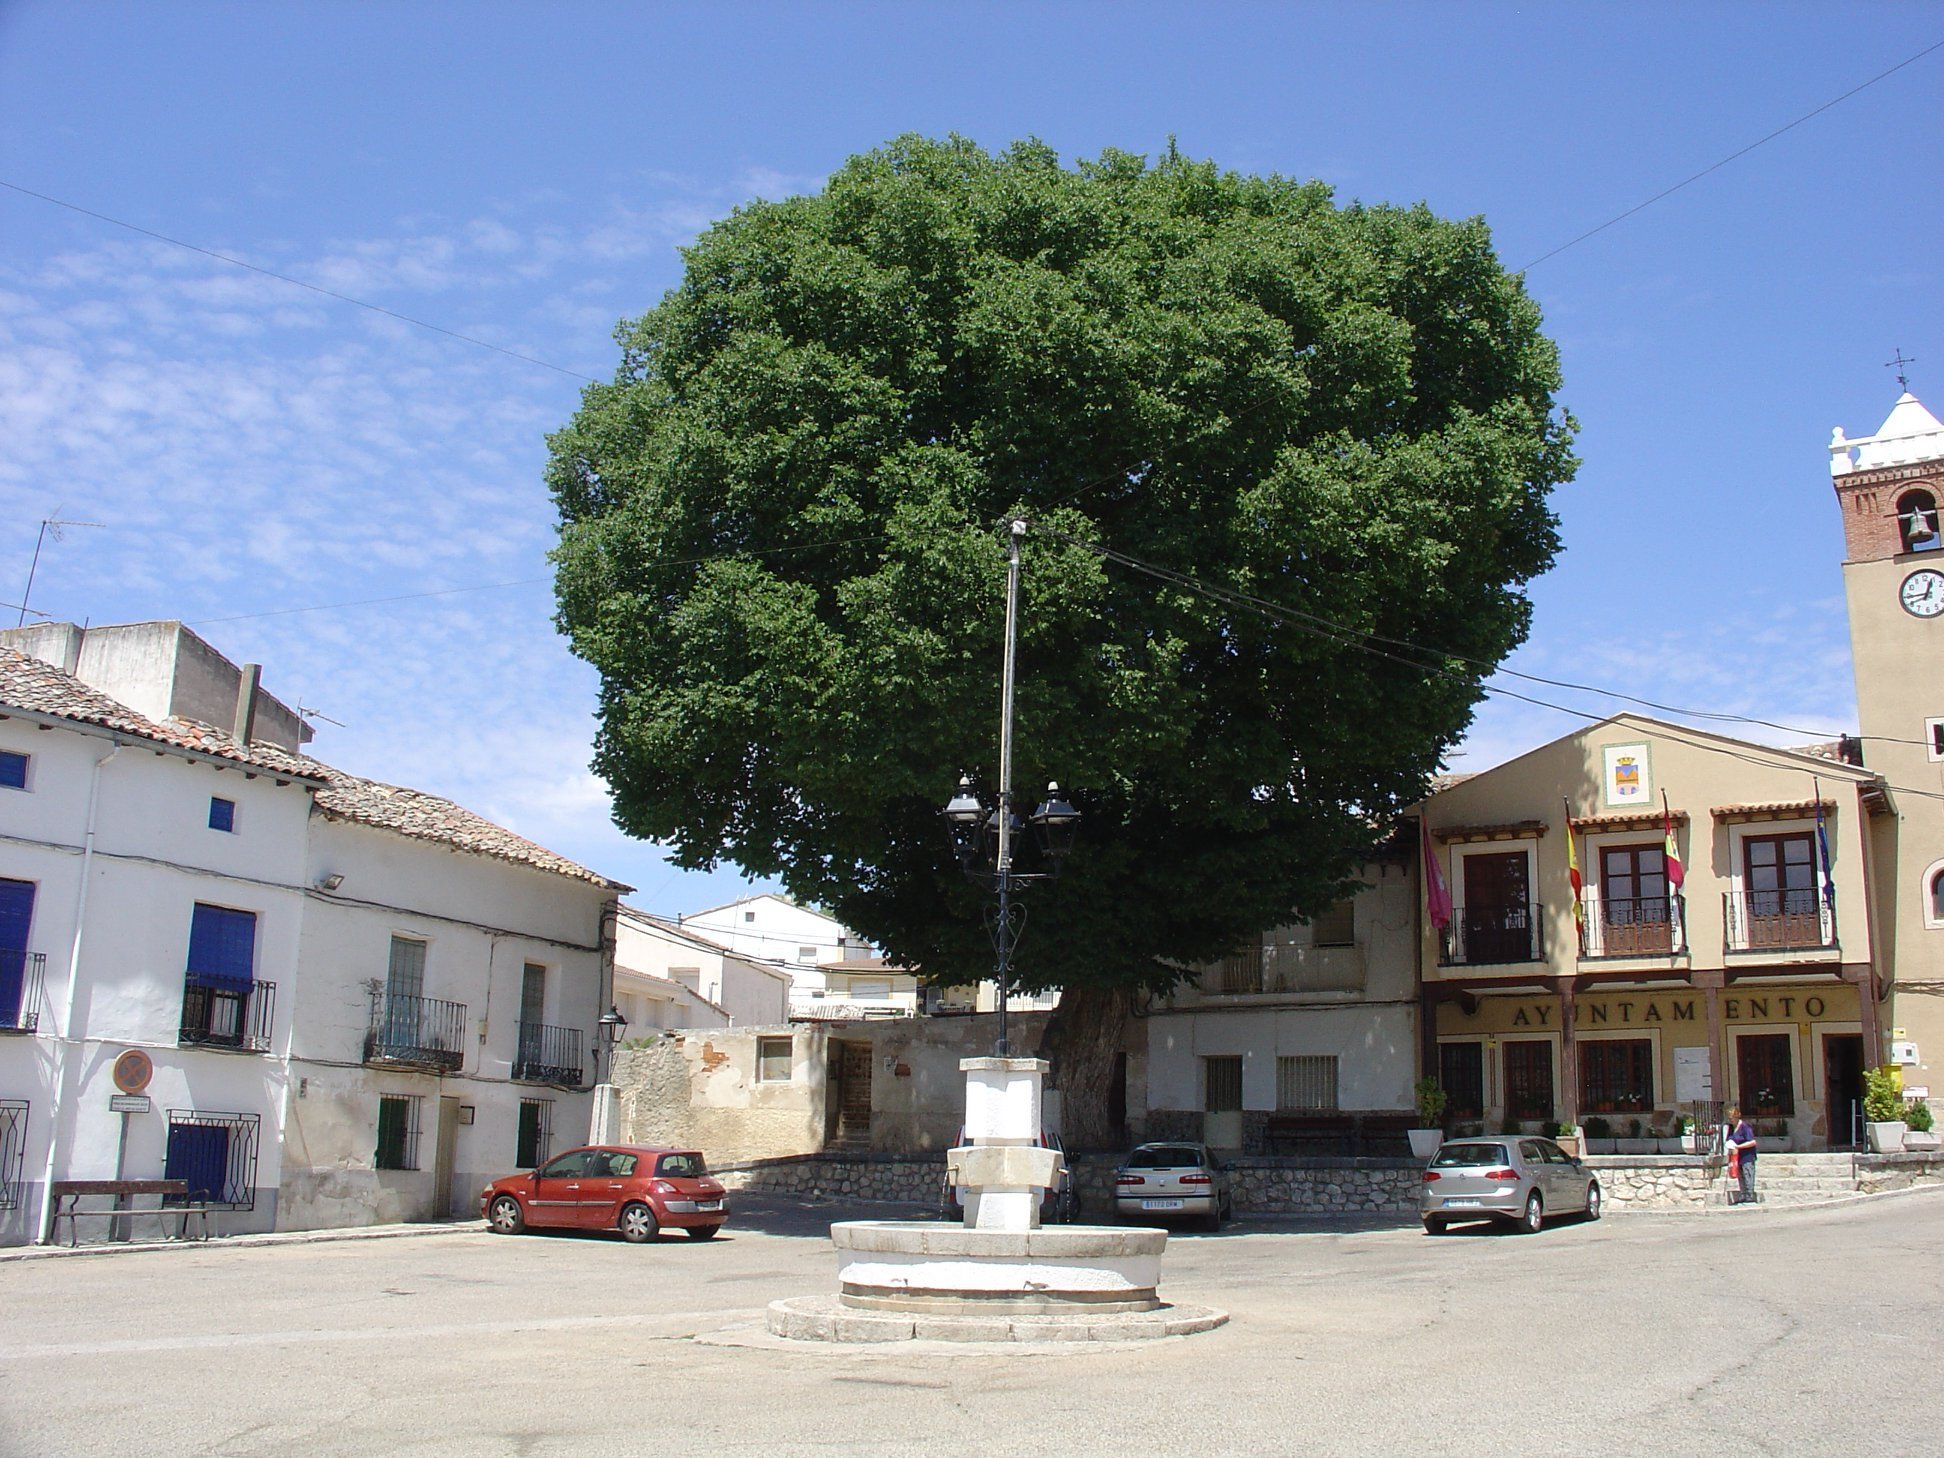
[0,717,612,1244]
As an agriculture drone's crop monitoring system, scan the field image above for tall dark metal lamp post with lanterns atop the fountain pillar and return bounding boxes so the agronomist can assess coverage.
[941,521,1081,1058]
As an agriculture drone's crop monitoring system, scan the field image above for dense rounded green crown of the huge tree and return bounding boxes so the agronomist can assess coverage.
[548,136,1575,1143]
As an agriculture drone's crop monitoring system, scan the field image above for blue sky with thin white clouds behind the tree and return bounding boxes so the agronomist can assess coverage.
[0,0,1944,912]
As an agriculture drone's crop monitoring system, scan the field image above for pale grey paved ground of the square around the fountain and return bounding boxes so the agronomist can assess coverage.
[0,1192,1944,1458]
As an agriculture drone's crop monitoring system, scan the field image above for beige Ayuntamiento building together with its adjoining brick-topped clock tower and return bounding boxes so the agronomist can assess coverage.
[1417,395,1944,1149]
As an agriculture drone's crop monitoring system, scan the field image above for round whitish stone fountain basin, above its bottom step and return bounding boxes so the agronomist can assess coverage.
[830,1221,1168,1316]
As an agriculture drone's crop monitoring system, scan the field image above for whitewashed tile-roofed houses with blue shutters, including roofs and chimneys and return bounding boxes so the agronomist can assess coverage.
[0,624,624,1244]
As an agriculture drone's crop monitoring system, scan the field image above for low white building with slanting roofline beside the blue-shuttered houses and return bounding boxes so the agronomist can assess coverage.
[614,902,791,1028]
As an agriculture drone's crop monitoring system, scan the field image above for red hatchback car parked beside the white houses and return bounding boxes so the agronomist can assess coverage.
[480,1145,729,1244]
